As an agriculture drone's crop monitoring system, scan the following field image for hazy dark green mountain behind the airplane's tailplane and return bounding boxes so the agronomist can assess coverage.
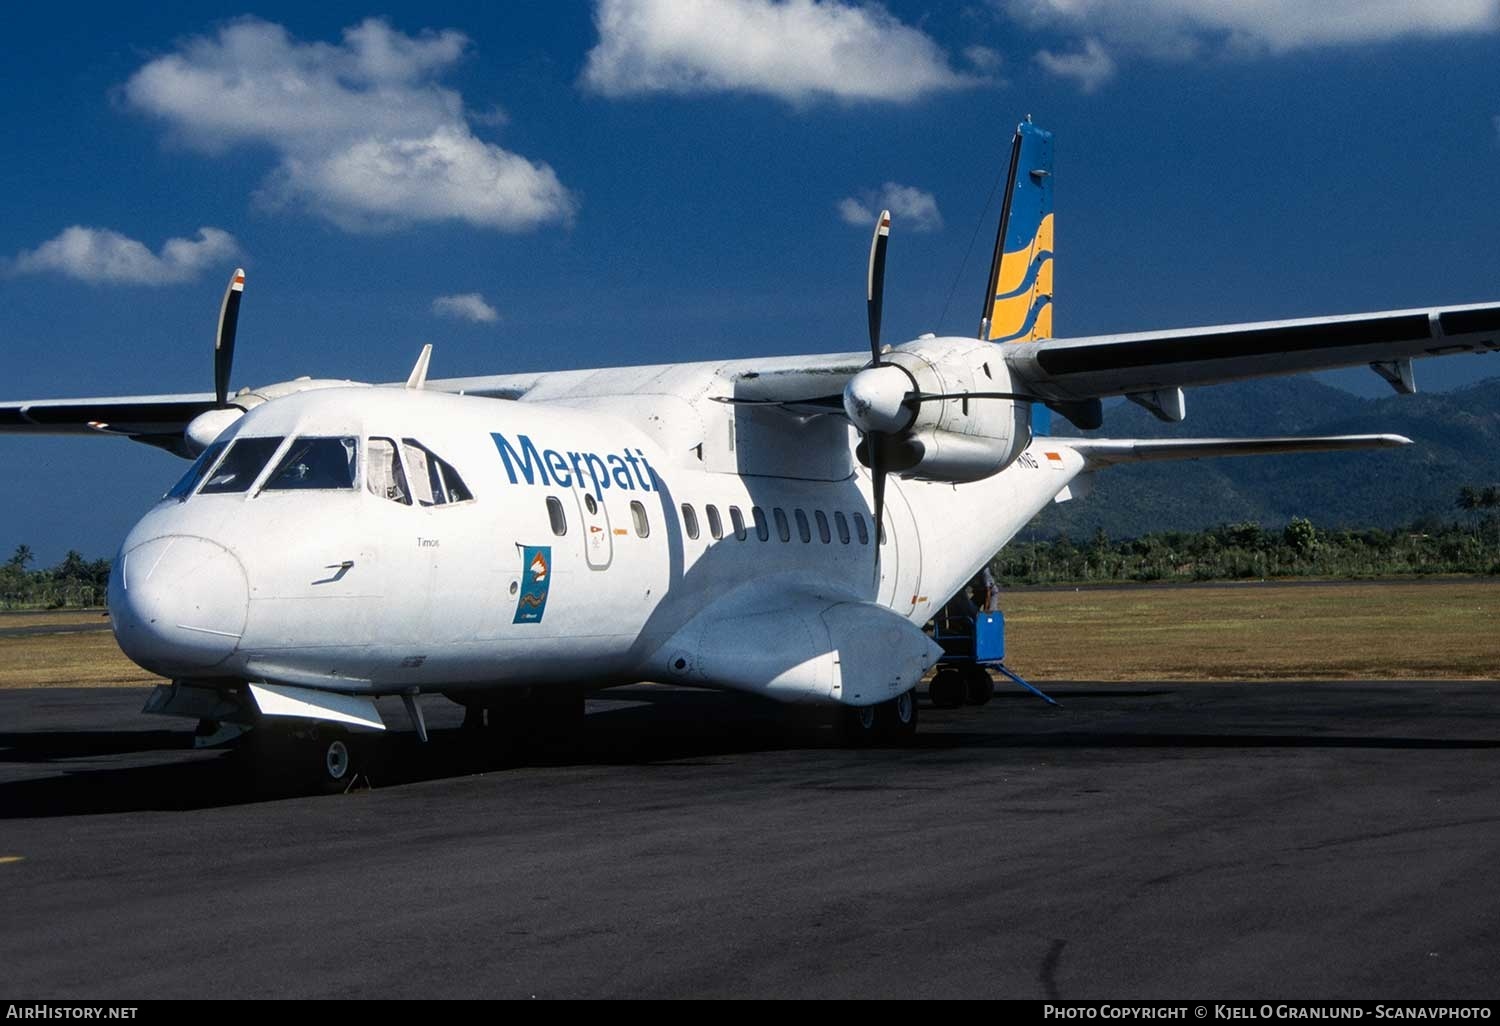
[1023,378,1500,539]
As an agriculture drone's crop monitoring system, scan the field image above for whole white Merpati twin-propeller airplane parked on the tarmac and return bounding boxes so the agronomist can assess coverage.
[0,119,1500,786]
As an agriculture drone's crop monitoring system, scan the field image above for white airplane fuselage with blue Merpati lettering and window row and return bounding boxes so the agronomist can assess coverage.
[111,387,1082,705]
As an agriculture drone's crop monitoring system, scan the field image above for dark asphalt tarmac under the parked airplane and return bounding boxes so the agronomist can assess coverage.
[0,683,1500,999]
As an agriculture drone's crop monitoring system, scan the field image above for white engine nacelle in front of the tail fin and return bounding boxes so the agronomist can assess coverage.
[846,338,1031,482]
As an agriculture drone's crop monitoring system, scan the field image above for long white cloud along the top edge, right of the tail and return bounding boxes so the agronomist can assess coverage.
[998,0,1500,57]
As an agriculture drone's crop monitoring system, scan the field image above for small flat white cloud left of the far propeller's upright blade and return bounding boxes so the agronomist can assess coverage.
[12,225,240,285]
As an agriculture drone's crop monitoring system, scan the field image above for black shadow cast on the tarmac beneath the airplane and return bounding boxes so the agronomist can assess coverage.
[0,687,1500,821]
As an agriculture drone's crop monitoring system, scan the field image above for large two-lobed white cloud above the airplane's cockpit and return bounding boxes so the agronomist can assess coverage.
[122,18,576,231]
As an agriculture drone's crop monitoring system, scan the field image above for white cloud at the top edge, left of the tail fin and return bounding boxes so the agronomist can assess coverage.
[581,0,980,104]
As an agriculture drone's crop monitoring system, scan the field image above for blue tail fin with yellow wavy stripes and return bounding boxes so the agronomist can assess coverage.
[980,117,1052,435]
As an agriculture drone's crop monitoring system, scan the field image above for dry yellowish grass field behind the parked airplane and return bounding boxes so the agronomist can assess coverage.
[0,581,1500,687]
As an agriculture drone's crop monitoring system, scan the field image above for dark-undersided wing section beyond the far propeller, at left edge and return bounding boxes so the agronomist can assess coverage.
[0,393,213,452]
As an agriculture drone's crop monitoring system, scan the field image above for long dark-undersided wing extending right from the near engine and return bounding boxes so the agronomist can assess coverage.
[1001,303,1500,402]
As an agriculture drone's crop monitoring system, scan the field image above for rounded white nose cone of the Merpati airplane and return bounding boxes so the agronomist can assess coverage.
[110,536,251,677]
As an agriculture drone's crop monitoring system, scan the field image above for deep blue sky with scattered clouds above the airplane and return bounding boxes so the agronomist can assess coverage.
[0,0,1500,563]
